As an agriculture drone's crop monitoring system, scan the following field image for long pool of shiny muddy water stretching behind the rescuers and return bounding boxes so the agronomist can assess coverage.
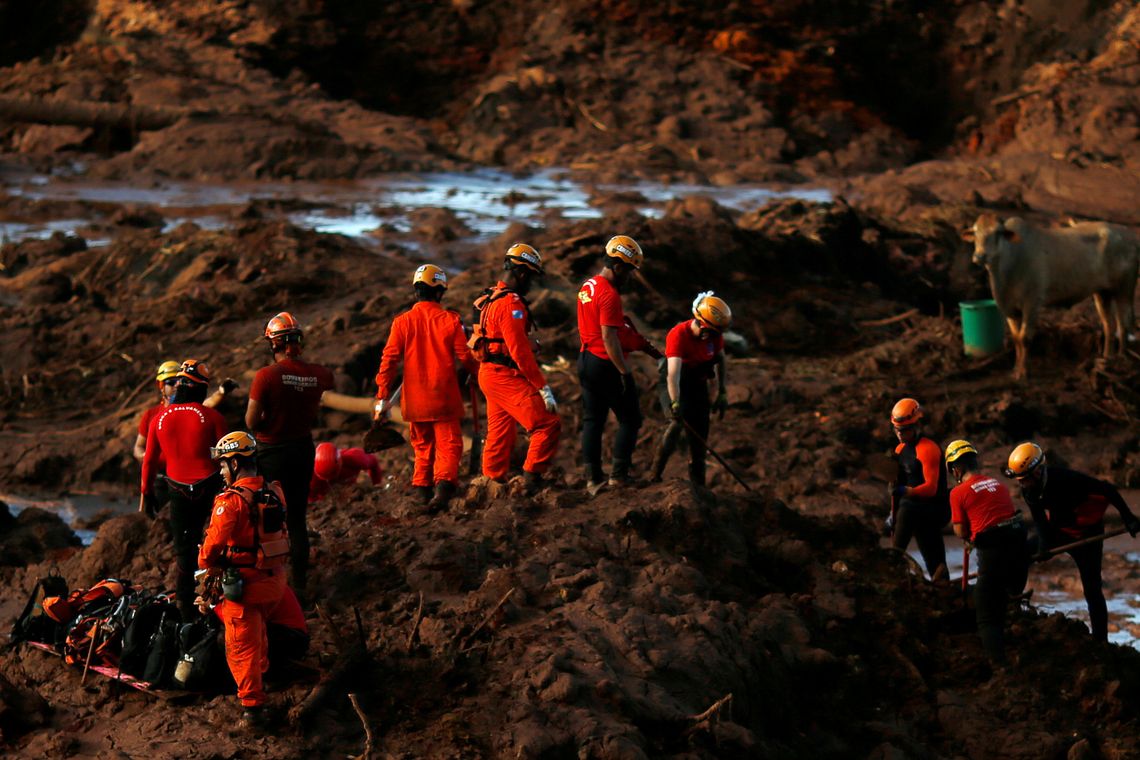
[0,169,831,253]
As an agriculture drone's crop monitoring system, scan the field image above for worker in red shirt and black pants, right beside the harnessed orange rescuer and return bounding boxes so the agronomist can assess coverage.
[578,235,661,496]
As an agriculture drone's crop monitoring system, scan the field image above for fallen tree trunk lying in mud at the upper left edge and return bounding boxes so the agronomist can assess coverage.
[0,97,203,131]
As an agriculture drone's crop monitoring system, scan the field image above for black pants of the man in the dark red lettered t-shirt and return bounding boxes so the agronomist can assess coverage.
[258,439,315,595]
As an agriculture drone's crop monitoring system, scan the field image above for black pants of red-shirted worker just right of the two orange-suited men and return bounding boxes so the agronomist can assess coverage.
[578,351,642,482]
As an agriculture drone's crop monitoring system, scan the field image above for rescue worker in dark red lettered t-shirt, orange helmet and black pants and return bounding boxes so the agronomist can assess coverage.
[245,311,333,597]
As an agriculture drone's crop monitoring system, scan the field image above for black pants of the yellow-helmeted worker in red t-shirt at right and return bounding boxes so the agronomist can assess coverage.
[974,524,1029,662]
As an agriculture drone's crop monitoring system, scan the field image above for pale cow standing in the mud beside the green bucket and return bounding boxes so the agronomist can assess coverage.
[966,214,1140,379]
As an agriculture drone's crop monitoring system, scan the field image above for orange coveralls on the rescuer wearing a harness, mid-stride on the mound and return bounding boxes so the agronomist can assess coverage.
[479,281,562,480]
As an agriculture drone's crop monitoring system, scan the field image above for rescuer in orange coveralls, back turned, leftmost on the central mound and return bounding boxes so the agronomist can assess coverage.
[373,264,479,510]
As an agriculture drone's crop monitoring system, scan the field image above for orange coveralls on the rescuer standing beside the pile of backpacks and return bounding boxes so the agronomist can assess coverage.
[198,476,285,708]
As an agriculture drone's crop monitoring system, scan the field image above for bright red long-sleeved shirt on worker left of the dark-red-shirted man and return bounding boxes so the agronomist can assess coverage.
[143,403,227,493]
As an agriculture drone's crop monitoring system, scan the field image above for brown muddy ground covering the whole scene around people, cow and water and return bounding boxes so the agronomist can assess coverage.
[0,0,1140,759]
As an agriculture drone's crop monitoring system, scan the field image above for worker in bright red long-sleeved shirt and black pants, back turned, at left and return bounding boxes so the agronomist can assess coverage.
[139,359,226,619]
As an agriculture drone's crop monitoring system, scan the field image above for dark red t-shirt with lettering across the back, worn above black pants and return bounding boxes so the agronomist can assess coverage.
[250,357,333,443]
